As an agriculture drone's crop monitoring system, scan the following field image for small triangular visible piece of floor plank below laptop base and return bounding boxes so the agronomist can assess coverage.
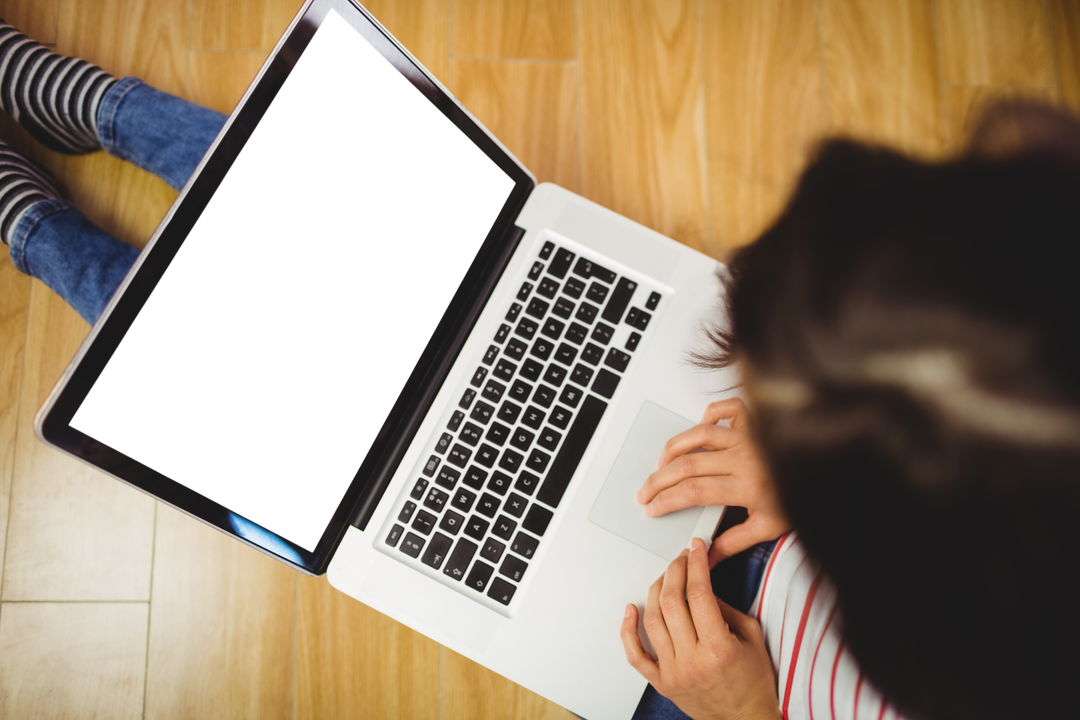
[442,649,575,720]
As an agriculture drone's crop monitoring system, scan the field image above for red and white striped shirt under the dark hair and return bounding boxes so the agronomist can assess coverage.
[750,532,903,720]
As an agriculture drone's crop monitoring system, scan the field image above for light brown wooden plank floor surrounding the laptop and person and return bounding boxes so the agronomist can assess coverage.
[0,0,1080,719]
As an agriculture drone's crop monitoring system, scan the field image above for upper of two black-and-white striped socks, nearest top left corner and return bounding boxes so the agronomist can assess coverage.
[0,19,117,155]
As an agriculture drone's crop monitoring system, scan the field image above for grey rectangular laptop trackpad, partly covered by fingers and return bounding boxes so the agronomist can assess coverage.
[589,402,718,560]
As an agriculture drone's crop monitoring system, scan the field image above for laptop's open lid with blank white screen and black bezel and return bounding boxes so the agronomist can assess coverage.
[36,0,535,574]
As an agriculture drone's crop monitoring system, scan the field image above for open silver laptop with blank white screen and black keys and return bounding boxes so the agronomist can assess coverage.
[36,0,735,720]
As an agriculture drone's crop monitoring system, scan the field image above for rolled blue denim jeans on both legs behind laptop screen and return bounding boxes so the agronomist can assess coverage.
[9,78,226,325]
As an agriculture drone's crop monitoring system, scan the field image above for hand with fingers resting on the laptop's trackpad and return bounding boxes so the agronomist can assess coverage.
[637,397,792,566]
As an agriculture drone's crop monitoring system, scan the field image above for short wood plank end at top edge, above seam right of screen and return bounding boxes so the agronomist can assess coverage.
[454,0,577,60]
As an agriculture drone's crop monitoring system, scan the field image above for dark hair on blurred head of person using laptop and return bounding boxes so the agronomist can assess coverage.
[712,104,1080,719]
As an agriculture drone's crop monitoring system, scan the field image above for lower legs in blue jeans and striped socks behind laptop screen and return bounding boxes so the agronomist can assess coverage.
[0,19,226,325]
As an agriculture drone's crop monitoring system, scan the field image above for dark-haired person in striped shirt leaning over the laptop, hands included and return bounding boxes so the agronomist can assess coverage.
[621,101,1080,720]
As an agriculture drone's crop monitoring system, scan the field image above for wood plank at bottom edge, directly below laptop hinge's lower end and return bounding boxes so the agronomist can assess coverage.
[296,576,440,720]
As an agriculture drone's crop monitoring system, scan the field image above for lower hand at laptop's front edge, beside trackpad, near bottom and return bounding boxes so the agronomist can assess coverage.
[620,538,781,720]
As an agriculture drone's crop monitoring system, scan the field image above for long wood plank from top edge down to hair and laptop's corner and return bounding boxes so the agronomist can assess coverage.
[702,0,826,258]
